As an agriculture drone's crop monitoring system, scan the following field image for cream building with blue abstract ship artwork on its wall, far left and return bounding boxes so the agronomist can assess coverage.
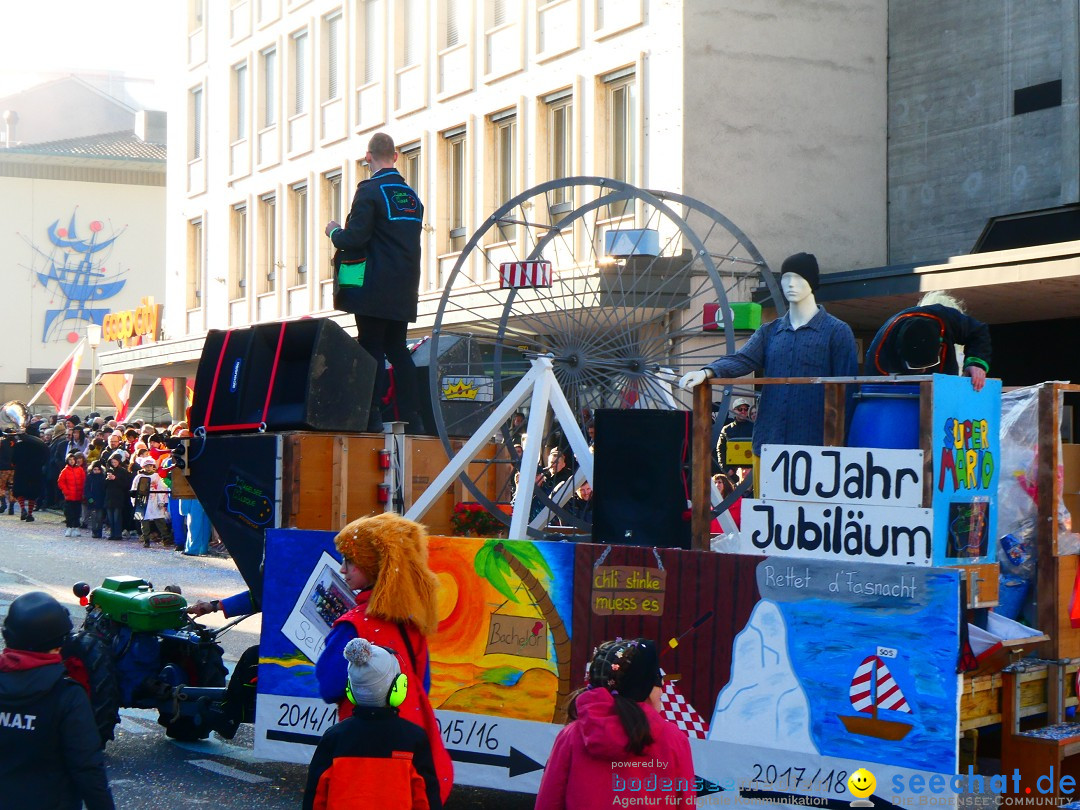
[0,78,165,410]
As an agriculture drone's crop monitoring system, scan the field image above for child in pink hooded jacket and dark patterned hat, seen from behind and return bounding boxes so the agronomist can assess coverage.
[536,638,697,810]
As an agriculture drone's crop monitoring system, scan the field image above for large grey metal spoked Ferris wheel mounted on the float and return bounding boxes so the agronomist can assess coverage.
[429,177,775,535]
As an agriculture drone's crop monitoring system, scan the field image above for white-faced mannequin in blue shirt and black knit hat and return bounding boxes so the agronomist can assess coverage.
[679,253,859,455]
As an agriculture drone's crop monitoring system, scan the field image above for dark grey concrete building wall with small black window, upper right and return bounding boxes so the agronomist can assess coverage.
[889,0,1080,264]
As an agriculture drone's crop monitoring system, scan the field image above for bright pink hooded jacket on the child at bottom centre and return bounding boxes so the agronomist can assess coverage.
[536,689,697,810]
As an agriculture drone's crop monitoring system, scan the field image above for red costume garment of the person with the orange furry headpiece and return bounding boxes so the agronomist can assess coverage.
[334,591,454,802]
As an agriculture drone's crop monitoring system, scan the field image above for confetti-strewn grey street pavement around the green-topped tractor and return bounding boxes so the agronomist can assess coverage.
[0,512,534,810]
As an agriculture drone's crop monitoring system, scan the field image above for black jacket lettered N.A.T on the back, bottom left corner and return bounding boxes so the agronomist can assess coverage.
[0,650,113,810]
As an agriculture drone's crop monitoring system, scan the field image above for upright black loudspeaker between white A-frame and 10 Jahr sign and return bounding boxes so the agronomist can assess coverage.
[593,409,691,549]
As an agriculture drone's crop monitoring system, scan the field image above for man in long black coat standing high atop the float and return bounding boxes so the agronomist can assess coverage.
[326,132,423,433]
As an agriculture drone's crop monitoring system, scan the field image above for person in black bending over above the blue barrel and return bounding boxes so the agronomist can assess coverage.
[865,292,990,391]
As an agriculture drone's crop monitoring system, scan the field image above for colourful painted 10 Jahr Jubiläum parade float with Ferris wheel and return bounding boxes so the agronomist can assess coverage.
[69,178,1080,807]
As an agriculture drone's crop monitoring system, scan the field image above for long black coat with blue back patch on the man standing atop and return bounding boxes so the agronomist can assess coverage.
[330,168,423,322]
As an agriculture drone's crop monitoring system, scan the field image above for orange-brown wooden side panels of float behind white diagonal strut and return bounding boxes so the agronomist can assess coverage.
[281,433,498,535]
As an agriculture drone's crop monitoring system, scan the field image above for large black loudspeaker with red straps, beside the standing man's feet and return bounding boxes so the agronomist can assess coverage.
[190,318,375,433]
